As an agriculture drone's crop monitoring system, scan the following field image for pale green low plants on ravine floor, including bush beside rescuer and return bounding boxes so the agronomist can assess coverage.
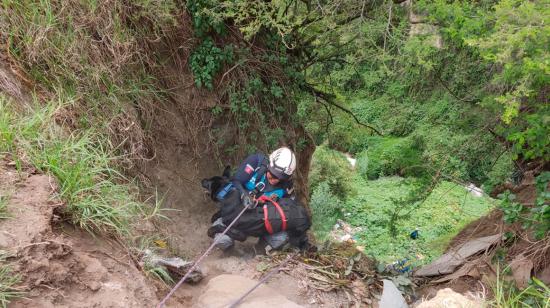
[310,146,496,265]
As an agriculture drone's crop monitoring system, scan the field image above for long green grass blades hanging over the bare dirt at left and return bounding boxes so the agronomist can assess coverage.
[0,96,146,235]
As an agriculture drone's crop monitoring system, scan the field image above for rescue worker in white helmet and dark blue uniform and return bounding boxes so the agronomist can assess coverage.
[213,147,296,250]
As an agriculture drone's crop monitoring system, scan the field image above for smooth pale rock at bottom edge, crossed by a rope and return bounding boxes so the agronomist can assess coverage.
[193,275,302,308]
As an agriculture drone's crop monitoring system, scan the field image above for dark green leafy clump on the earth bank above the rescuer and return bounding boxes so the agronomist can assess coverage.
[189,38,233,90]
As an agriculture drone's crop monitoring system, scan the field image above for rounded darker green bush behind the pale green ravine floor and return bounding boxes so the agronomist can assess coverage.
[357,137,423,179]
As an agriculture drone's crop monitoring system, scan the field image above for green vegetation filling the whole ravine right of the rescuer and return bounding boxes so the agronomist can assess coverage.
[304,0,550,262]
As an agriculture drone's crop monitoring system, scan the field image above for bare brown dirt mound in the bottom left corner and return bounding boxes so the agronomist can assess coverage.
[0,161,164,307]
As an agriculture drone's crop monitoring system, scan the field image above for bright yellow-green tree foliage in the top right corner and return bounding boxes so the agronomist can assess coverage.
[419,0,550,164]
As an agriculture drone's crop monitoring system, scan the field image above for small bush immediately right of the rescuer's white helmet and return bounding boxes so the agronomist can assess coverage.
[309,145,353,200]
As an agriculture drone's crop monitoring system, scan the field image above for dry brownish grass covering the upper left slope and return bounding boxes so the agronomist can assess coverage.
[0,0,181,165]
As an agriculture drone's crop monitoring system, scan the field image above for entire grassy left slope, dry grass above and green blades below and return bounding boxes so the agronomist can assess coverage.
[0,1,179,235]
